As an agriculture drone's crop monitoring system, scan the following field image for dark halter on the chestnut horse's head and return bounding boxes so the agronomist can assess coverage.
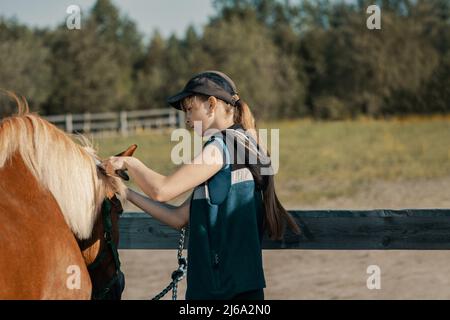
[88,198,125,300]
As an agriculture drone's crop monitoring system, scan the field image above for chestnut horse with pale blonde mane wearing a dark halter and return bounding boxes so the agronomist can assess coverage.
[0,97,136,299]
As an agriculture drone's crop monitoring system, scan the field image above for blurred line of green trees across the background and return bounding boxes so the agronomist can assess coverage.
[0,0,450,119]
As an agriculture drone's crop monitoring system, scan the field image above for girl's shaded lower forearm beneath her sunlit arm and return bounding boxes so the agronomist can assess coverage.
[127,189,191,230]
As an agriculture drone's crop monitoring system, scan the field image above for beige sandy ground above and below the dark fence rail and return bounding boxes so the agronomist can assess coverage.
[120,177,450,299]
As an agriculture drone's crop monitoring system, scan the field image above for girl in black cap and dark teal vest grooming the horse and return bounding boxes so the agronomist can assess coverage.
[104,71,299,299]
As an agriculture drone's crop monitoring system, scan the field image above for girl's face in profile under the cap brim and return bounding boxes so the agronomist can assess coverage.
[183,96,214,136]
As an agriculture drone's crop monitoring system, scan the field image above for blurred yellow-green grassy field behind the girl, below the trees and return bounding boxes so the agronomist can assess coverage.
[94,117,450,207]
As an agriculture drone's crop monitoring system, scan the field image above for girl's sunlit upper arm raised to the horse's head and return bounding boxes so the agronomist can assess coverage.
[104,144,223,202]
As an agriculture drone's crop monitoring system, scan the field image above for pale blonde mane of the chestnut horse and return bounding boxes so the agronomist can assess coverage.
[0,92,126,240]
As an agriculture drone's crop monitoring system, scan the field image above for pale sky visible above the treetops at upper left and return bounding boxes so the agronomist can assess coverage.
[0,0,214,37]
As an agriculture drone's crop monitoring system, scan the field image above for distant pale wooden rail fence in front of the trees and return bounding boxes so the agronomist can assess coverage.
[45,108,184,135]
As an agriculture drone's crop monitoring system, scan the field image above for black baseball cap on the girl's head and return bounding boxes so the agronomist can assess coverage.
[167,70,239,110]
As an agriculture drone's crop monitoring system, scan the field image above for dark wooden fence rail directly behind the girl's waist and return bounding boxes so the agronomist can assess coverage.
[119,209,450,250]
